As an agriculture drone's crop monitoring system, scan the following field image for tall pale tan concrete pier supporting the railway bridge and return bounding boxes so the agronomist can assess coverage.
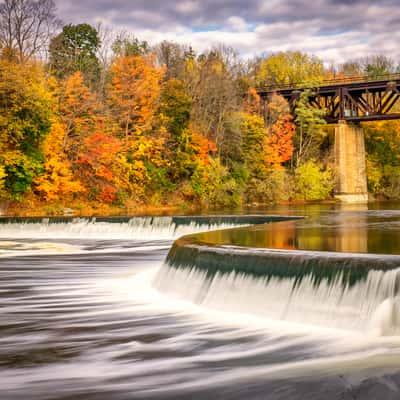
[335,121,368,203]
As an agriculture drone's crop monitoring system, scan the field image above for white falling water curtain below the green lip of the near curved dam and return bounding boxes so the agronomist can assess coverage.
[154,265,400,335]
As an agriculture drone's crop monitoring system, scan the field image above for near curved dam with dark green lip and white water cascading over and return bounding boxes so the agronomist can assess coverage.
[155,216,400,335]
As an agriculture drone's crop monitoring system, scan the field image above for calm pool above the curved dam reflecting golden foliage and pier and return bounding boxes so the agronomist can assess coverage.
[195,206,400,254]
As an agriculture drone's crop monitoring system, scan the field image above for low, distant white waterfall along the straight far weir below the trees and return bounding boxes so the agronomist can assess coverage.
[0,216,285,241]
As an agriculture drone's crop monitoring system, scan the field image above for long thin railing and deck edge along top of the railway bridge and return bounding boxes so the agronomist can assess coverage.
[258,73,400,92]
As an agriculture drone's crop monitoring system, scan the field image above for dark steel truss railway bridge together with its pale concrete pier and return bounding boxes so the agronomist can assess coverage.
[258,74,400,203]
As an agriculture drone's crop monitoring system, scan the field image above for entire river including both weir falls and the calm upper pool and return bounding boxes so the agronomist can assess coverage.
[0,208,400,400]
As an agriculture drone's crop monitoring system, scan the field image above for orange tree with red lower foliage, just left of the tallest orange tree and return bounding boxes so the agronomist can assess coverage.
[59,72,122,203]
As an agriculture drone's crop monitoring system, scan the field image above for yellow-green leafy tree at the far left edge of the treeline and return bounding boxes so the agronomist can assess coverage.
[0,59,53,200]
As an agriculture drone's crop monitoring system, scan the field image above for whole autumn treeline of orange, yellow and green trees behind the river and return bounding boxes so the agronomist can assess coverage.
[0,0,400,213]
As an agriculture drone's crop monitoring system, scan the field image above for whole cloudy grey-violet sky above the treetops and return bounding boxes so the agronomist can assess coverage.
[55,0,400,64]
